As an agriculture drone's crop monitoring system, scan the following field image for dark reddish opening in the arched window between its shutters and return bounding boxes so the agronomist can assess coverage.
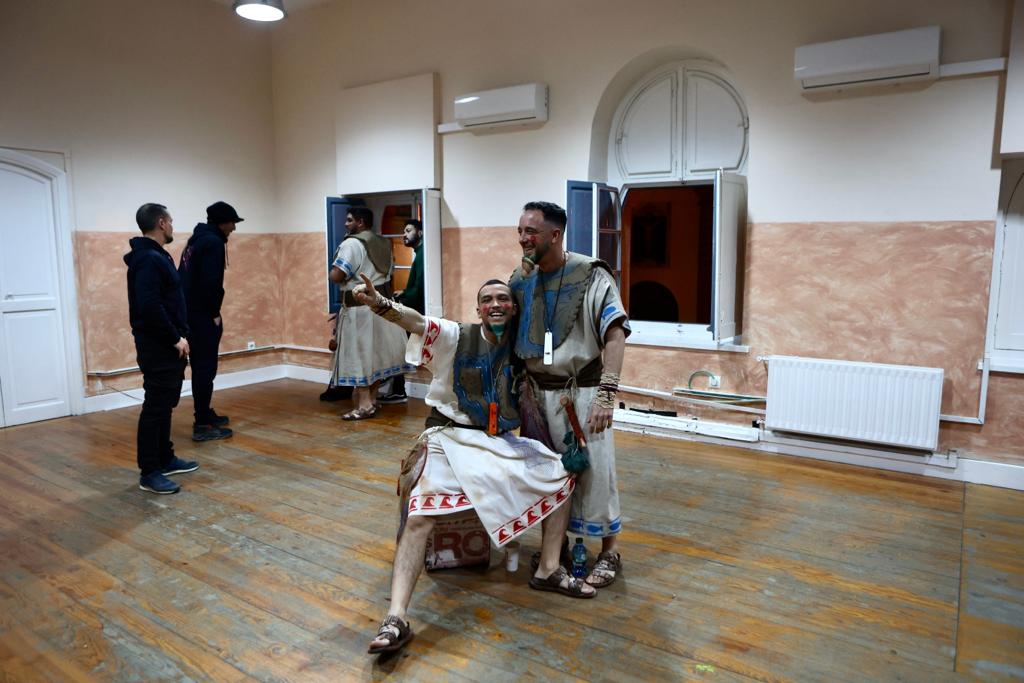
[622,184,715,325]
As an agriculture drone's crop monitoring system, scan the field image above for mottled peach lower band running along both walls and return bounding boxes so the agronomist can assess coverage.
[76,221,1024,471]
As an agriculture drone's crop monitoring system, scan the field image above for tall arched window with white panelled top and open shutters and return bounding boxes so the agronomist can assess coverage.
[567,59,749,348]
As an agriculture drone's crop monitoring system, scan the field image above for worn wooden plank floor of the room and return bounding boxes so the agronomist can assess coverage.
[0,380,1024,682]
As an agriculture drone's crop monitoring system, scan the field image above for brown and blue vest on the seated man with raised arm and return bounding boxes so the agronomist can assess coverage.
[452,323,519,433]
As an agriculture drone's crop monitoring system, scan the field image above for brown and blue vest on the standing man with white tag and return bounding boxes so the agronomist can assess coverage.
[509,252,611,358]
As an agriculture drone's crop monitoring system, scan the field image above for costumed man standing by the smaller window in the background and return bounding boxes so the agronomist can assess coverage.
[330,207,406,420]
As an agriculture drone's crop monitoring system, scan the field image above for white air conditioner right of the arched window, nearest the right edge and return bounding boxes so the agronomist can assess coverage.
[793,26,940,92]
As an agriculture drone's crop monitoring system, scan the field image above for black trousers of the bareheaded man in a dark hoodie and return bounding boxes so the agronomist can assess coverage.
[135,343,185,476]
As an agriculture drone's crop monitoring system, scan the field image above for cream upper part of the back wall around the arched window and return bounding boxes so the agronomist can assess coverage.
[272,0,1006,230]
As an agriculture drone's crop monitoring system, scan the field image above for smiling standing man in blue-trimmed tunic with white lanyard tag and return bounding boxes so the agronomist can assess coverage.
[510,202,630,588]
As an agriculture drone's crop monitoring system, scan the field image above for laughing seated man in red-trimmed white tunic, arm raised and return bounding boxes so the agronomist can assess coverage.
[352,275,595,654]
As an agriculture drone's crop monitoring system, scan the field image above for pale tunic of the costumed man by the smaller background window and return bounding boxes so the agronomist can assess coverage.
[331,239,413,386]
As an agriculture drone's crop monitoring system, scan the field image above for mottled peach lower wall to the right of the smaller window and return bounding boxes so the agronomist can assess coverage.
[443,221,1024,464]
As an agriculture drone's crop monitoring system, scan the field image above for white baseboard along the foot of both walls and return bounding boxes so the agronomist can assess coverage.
[84,365,1024,490]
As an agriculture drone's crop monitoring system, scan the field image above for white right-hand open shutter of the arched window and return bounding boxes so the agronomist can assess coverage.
[711,169,746,342]
